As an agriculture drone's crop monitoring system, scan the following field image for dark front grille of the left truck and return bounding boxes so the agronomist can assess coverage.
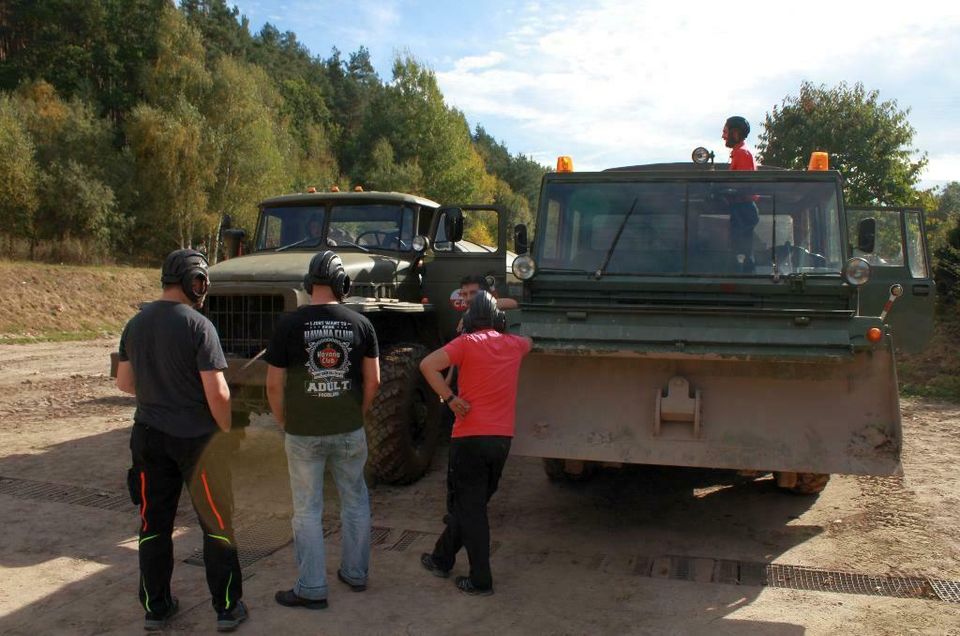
[205,295,283,358]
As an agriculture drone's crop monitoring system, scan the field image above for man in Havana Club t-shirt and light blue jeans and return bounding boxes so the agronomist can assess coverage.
[266,251,380,609]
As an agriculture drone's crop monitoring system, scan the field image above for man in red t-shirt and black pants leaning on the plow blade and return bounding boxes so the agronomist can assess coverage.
[420,291,533,596]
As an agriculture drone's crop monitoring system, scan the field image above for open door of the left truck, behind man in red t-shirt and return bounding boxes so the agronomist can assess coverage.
[423,205,508,340]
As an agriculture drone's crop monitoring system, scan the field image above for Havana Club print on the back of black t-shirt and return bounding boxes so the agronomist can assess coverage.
[303,320,353,398]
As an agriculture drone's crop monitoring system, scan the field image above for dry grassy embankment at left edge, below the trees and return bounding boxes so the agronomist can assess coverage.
[0,261,160,344]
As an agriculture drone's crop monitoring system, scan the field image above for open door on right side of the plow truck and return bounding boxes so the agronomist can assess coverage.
[847,207,936,353]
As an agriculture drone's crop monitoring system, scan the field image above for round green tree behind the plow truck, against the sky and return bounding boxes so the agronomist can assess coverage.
[757,82,927,205]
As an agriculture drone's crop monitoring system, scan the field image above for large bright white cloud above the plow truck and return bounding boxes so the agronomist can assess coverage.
[437,0,960,171]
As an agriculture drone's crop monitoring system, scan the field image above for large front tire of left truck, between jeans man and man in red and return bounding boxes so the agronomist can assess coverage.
[365,344,440,484]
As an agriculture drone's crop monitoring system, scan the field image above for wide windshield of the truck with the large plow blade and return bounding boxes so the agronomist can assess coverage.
[536,179,842,276]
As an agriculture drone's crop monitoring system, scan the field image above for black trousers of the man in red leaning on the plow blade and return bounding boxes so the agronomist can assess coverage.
[433,435,511,590]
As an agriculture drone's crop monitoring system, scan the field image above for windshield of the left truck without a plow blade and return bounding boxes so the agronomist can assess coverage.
[256,203,414,251]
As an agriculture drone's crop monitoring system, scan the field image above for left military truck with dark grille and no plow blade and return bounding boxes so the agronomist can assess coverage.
[203,192,512,483]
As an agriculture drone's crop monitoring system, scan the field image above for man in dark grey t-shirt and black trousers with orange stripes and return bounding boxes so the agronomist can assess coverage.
[117,250,247,631]
